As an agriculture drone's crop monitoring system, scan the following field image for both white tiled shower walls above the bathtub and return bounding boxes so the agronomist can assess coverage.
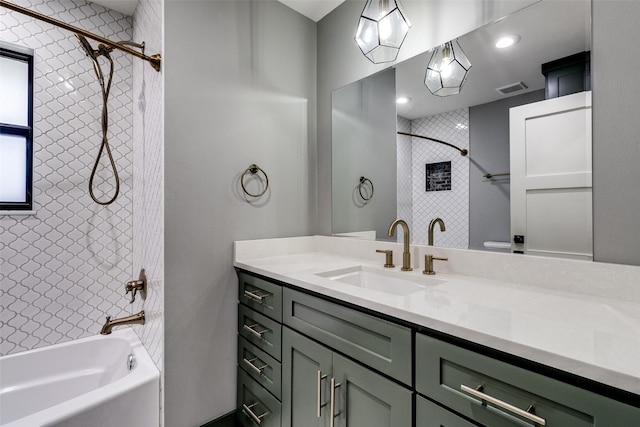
[0,0,164,369]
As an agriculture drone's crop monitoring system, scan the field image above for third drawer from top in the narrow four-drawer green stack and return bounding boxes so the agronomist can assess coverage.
[238,337,282,399]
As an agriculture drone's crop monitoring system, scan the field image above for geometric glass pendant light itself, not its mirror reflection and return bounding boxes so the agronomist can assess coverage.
[355,0,411,64]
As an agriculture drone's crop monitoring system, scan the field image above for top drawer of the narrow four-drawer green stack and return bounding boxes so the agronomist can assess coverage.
[238,272,282,322]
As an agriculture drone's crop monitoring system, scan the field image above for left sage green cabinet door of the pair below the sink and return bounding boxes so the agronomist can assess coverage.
[282,326,332,427]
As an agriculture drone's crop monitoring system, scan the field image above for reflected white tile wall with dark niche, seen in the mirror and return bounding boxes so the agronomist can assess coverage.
[411,108,469,249]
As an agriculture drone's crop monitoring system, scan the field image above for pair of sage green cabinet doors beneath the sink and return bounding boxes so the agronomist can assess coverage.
[282,327,413,427]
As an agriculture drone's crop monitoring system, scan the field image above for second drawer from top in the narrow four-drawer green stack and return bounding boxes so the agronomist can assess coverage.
[238,304,282,360]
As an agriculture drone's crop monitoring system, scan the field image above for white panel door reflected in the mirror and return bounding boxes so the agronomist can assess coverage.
[509,92,593,260]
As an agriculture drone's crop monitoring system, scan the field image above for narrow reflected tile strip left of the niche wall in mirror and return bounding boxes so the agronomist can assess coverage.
[396,116,413,237]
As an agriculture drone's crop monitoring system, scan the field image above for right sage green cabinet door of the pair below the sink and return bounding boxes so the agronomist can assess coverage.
[329,353,412,427]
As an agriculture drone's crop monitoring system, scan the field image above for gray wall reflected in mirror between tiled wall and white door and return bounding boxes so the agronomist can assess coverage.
[469,89,544,249]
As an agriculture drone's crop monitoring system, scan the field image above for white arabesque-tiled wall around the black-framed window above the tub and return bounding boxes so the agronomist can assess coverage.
[0,0,132,355]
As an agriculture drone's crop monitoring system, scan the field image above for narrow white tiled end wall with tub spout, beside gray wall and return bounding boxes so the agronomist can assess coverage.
[131,0,164,370]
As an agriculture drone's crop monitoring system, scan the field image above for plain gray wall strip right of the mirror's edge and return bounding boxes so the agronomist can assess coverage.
[591,0,640,265]
